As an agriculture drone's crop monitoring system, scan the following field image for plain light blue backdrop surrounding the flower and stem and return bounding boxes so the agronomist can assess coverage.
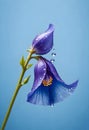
[0,0,89,130]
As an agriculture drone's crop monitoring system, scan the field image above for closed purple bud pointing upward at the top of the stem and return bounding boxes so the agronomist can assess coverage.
[32,24,54,55]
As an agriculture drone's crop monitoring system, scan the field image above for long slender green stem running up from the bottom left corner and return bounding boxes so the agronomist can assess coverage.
[0,52,33,130]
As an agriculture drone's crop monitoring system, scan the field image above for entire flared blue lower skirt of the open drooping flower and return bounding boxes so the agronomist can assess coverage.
[27,77,77,106]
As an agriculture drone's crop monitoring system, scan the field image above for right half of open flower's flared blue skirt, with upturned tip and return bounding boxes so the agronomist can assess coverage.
[50,78,78,104]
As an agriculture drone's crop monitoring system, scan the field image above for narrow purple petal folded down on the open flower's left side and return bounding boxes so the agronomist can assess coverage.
[32,59,46,90]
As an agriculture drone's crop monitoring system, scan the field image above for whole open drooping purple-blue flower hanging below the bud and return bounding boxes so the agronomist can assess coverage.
[27,57,78,105]
